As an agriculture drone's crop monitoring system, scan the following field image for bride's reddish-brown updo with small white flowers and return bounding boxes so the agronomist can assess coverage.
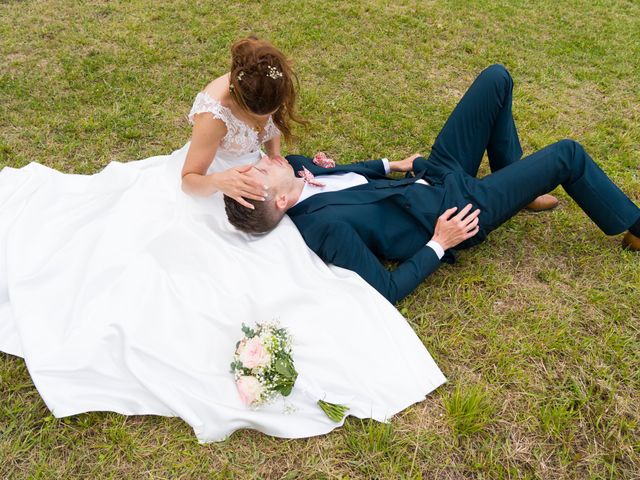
[229,36,307,141]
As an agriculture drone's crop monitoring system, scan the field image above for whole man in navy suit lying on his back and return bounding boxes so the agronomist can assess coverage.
[224,65,640,303]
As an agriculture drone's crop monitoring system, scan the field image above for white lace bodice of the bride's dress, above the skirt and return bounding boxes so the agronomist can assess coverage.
[188,91,280,170]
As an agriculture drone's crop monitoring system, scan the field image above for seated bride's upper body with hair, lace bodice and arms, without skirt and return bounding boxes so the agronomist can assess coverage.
[182,38,304,208]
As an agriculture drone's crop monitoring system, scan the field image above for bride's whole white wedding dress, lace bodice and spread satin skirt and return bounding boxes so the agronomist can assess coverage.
[0,92,445,442]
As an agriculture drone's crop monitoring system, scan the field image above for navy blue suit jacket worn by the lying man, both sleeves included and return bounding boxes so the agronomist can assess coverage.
[286,155,453,303]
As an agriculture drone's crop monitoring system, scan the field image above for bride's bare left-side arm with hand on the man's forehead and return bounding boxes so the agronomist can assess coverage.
[182,113,264,208]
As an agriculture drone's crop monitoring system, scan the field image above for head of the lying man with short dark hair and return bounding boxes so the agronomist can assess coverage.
[224,157,297,234]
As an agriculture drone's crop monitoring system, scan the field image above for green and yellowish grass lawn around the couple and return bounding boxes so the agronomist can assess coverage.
[0,0,640,479]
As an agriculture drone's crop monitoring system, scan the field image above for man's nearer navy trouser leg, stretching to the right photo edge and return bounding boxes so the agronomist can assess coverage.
[464,140,640,246]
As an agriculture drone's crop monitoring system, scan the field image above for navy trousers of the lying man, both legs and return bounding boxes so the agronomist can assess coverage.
[428,65,640,244]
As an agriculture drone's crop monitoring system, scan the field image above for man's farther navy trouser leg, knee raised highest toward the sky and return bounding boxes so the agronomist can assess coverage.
[429,64,524,177]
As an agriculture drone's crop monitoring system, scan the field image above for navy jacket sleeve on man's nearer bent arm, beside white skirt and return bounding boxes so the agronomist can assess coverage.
[305,222,440,303]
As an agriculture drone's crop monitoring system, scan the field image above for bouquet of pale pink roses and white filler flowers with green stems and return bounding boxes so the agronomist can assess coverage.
[231,322,348,422]
